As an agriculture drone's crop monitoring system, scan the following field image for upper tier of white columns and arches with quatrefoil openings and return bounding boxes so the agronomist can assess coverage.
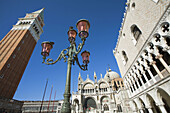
[124,23,170,95]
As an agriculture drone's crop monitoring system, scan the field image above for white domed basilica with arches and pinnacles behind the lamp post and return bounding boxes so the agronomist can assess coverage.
[72,69,129,113]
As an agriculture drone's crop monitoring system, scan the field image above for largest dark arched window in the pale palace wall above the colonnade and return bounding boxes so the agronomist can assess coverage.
[131,25,142,44]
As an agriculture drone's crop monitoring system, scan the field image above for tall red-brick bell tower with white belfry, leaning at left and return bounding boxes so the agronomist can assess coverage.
[0,8,44,99]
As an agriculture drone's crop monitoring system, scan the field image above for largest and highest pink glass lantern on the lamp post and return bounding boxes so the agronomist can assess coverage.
[76,19,90,38]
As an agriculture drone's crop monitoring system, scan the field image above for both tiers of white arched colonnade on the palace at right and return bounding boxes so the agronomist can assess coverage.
[124,22,170,113]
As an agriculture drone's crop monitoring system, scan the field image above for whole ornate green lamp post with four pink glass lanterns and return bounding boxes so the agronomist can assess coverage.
[41,19,90,113]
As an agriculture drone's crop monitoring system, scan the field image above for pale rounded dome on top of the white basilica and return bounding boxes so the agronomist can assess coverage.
[104,69,120,81]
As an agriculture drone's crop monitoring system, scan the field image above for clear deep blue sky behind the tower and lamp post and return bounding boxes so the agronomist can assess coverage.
[0,0,126,100]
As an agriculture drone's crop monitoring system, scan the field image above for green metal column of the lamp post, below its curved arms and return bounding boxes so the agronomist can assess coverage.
[61,58,72,113]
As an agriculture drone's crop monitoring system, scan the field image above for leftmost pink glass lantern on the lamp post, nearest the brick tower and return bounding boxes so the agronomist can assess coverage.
[41,41,54,57]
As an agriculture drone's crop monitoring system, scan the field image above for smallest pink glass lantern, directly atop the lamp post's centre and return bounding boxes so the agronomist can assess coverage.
[67,27,77,42]
